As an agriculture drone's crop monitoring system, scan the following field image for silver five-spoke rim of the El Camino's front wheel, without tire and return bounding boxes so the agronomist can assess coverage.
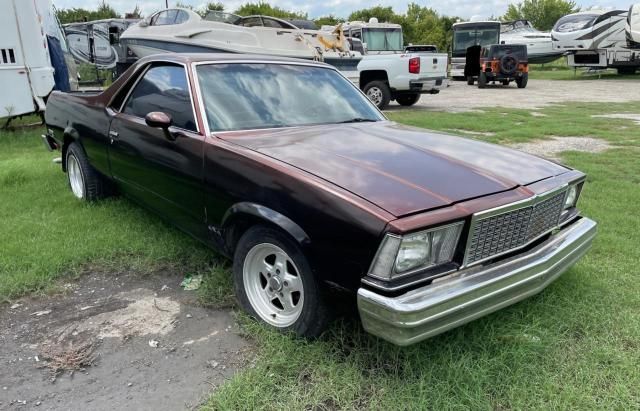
[242,243,304,328]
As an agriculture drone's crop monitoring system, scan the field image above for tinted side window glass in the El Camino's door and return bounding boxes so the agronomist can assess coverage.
[122,66,197,131]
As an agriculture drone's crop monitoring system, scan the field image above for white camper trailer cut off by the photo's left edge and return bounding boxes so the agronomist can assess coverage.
[0,0,73,119]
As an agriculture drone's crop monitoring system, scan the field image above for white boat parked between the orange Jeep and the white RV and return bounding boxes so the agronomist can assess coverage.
[500,20,563,64]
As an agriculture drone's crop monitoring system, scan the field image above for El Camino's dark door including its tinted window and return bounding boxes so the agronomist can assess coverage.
[109,64,206,237]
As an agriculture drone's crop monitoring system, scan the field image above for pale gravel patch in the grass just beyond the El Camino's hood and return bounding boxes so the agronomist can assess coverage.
[510,137,611,161]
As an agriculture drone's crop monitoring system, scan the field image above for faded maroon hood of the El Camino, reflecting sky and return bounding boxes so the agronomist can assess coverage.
[218,121,568,217]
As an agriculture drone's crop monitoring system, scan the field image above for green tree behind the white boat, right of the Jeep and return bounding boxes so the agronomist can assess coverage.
[500,0,580,30]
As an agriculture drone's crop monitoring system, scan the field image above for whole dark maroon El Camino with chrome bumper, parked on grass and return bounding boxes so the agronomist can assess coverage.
[43,54,596,345]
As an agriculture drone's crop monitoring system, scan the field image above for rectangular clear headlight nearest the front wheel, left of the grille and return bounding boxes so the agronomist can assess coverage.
[369,221,464,280]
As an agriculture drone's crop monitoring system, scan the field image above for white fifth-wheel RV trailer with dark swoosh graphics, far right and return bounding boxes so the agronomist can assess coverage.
[551,10,640,74]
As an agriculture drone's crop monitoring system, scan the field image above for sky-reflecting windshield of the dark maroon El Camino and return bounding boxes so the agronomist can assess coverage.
[197,63,384,131]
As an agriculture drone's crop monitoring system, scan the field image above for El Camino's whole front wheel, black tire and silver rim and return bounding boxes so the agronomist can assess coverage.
[233,225,331,338]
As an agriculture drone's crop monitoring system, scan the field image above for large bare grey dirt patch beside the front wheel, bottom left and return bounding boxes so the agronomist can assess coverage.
[0,272,252,410]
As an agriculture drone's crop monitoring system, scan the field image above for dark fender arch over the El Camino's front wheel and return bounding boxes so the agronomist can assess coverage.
[221,202,311,254]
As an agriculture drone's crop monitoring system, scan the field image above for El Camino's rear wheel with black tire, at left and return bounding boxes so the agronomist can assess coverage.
[65,142,111,202]
